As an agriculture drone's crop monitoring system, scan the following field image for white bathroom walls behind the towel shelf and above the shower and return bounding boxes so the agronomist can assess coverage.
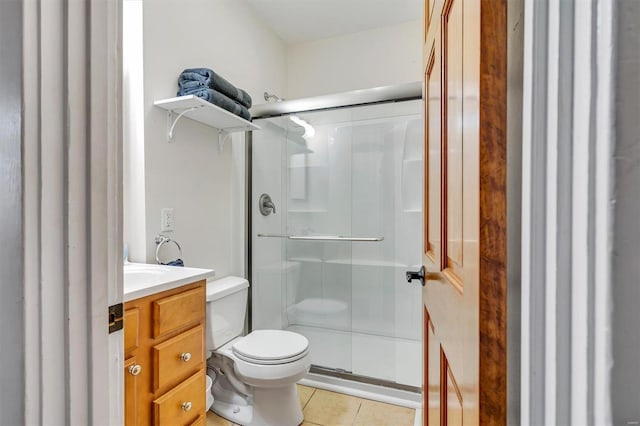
[124,5,421,276]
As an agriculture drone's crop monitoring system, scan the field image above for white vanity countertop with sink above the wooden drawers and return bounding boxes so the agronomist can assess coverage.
[124,262,216,302]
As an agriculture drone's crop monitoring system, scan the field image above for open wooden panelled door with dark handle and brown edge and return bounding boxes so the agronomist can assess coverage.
[423,0,507,426]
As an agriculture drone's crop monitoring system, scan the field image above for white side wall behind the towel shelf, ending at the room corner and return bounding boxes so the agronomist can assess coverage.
[125,0,286,276]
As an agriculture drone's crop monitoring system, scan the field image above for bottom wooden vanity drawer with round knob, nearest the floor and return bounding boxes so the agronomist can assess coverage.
[153,370,206,426]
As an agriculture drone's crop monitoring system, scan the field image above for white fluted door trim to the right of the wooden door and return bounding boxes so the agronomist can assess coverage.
[521,0,615,425]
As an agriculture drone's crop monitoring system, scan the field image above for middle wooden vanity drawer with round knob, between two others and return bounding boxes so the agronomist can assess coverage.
[152,325,204,392]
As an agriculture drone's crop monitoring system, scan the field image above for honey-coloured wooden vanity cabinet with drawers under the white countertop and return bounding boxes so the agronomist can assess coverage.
[124,280,206,426]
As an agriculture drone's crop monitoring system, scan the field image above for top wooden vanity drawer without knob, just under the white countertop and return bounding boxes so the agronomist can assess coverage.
[153,286,206,339]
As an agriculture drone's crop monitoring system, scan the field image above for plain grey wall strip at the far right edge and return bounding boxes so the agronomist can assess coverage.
[611,0,640,425]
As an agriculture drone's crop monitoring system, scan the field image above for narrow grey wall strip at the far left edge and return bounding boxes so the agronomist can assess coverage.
[0,1,23,424]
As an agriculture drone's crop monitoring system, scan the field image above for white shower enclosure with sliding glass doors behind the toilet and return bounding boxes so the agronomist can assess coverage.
[250,85,424,391]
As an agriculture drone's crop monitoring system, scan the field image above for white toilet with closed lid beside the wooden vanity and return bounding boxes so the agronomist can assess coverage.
[207,277,311,426]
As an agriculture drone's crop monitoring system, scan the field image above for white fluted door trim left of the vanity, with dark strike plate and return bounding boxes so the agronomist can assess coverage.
[22,0,123,425]
